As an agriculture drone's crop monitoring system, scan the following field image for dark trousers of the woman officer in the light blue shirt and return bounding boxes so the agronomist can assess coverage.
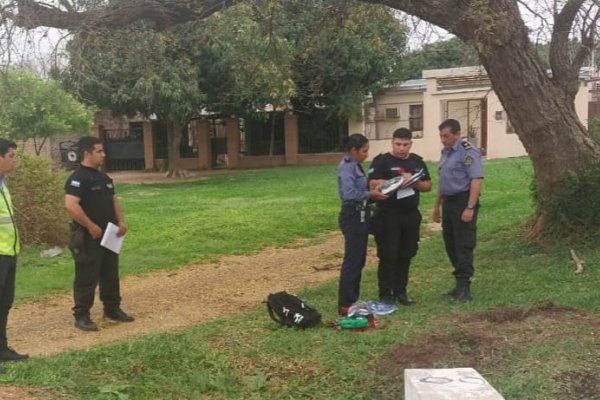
[338,203,369,310]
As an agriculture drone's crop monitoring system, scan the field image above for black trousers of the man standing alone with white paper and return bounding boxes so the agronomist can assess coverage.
[73,234,121,318]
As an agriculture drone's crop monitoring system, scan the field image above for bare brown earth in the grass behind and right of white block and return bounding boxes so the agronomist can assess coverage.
[377,302,600,400]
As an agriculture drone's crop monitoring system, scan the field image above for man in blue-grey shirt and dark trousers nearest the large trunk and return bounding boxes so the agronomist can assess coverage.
[433,119,483,302]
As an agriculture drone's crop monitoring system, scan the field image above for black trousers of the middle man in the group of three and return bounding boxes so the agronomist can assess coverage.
[373,207,422,299]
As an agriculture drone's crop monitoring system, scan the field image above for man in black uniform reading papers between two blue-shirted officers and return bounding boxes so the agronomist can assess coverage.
[369,128,431,306]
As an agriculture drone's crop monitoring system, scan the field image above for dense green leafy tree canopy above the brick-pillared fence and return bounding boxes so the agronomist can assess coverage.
[65,0,406,119]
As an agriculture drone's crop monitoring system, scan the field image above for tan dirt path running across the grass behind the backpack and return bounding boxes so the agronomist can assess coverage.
[8,233,373,356]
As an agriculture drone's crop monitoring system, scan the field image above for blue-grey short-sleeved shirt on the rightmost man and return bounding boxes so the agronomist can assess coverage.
[438,138,483,196]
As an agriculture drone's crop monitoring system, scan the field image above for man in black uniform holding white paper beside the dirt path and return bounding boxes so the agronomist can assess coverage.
[65,136,134,331]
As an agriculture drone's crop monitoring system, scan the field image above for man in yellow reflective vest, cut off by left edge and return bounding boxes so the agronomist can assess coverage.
[0,138,29,371]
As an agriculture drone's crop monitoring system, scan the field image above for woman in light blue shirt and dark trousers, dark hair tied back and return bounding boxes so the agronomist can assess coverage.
[337,133,387,314]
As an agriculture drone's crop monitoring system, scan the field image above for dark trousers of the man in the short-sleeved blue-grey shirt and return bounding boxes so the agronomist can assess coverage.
[442,192,479,282]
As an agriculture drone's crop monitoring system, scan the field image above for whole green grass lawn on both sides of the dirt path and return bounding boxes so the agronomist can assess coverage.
[5,158,600,400]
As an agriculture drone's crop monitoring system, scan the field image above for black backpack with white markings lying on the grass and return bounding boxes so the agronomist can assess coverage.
[267,292,321,329]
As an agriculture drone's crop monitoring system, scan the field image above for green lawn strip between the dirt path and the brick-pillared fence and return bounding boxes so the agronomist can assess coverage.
[17,165,338,301]
